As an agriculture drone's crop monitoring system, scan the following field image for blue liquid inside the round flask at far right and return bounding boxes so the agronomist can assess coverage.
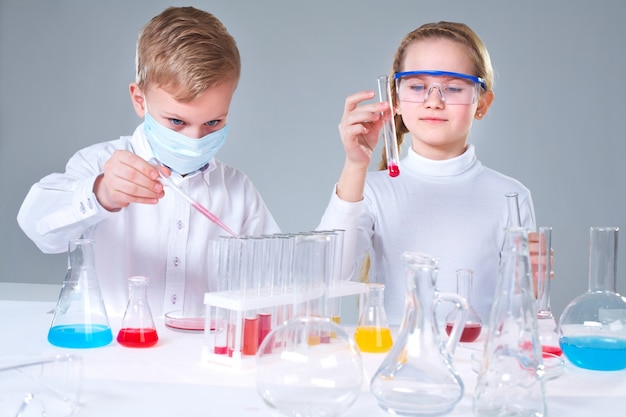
[559,336,626,371]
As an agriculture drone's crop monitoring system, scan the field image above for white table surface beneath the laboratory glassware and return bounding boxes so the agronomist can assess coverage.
[0,300,626,417]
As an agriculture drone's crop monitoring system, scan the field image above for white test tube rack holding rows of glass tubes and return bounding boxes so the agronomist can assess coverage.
[201,281,367,370]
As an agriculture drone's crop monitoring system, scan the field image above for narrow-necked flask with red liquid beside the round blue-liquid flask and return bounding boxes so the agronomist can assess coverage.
[537,226,562,358]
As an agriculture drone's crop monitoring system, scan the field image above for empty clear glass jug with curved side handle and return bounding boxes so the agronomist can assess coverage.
[370,252,467,416]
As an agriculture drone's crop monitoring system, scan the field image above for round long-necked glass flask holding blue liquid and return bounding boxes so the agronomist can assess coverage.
[559,227,626,371]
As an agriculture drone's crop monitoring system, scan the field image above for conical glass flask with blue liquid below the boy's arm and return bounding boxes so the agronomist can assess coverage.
[48,239,113,348]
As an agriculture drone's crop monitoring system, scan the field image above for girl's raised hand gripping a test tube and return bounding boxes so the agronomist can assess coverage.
[339,90,389,169]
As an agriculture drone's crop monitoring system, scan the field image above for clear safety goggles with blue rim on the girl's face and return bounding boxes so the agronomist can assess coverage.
[394,70,487,104]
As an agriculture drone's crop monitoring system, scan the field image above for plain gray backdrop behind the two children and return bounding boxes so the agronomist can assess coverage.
[0,0,626,316]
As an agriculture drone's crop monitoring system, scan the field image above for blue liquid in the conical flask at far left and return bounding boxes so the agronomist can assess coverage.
[48,324,113,348]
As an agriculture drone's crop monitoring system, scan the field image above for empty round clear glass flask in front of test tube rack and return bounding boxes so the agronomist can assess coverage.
[256,317,363,417]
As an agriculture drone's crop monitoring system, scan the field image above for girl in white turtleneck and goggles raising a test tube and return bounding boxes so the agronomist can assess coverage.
[320,22,535,324]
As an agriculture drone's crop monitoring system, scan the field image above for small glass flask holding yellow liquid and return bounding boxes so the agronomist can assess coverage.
[354,283,393,353]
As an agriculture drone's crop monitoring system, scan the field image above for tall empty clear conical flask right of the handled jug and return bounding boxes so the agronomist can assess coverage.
[473,227,546,417]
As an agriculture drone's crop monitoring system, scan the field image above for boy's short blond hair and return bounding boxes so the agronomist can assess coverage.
[136,7,241,102]
